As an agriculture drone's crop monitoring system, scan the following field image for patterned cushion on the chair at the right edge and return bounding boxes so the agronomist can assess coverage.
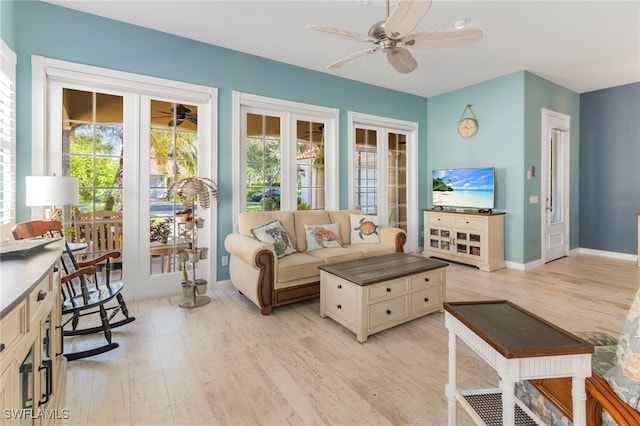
[604,291,640,411]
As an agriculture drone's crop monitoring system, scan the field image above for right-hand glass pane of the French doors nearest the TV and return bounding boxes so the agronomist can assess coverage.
[388,133,407,231]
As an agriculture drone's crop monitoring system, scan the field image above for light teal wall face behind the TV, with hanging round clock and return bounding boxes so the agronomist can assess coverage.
[424,72,525,263]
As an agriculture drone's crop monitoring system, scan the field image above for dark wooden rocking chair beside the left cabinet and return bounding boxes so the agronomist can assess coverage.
[11,220,135,361]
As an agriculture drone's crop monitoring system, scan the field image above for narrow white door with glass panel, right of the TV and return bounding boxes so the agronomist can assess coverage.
[541,108,570,263]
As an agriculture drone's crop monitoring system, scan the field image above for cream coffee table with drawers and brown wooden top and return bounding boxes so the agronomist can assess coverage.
[319,253,449,342]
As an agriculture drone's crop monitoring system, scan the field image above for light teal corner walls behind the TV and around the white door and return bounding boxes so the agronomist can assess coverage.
[424,71,580,263]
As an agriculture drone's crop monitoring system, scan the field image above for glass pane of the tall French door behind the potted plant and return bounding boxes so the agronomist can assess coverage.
[149,100,198,275]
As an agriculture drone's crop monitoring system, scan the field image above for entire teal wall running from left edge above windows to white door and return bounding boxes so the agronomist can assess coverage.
[0,0,596,280]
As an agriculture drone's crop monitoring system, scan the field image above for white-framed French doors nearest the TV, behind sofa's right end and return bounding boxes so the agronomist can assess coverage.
[348,111,418,252]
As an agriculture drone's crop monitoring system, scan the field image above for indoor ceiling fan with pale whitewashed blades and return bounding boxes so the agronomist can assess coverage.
[306,0,482,74]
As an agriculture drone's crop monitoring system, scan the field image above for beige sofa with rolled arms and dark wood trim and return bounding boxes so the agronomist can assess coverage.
[224,210,407,315]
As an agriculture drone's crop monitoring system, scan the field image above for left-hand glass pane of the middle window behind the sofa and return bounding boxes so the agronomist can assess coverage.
[245,114,282,211]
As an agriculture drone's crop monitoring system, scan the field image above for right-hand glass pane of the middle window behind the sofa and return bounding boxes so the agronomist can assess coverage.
[296,120,325,210]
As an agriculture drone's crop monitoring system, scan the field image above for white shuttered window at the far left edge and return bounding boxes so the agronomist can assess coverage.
[0,39,17,238]
